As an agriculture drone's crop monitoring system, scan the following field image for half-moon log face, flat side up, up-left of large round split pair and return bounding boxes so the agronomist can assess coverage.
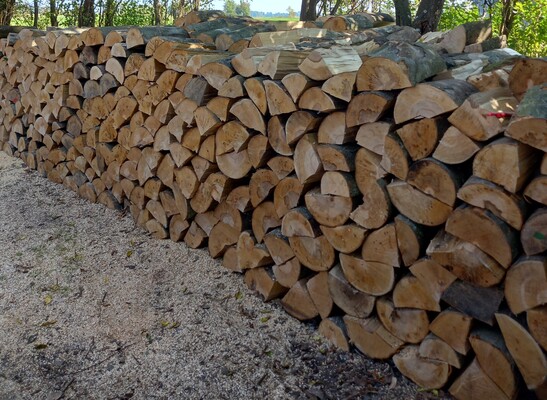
[387,180,452,226]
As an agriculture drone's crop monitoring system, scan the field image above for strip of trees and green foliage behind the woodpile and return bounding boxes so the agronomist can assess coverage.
[0,0,547,57]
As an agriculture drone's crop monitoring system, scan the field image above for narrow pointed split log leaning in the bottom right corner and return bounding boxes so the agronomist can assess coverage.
[496,314,547,390]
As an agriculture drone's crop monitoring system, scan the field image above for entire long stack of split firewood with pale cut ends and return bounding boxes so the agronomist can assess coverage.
[0,12,547,399]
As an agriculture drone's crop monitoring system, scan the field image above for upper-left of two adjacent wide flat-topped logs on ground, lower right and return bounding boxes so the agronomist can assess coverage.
[344,315,403,360]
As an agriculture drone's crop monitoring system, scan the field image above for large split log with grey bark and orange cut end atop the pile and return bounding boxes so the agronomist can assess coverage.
[356,42,446,91]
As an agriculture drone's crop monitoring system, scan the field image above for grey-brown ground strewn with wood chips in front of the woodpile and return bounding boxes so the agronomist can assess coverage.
[0,152,450,400]
